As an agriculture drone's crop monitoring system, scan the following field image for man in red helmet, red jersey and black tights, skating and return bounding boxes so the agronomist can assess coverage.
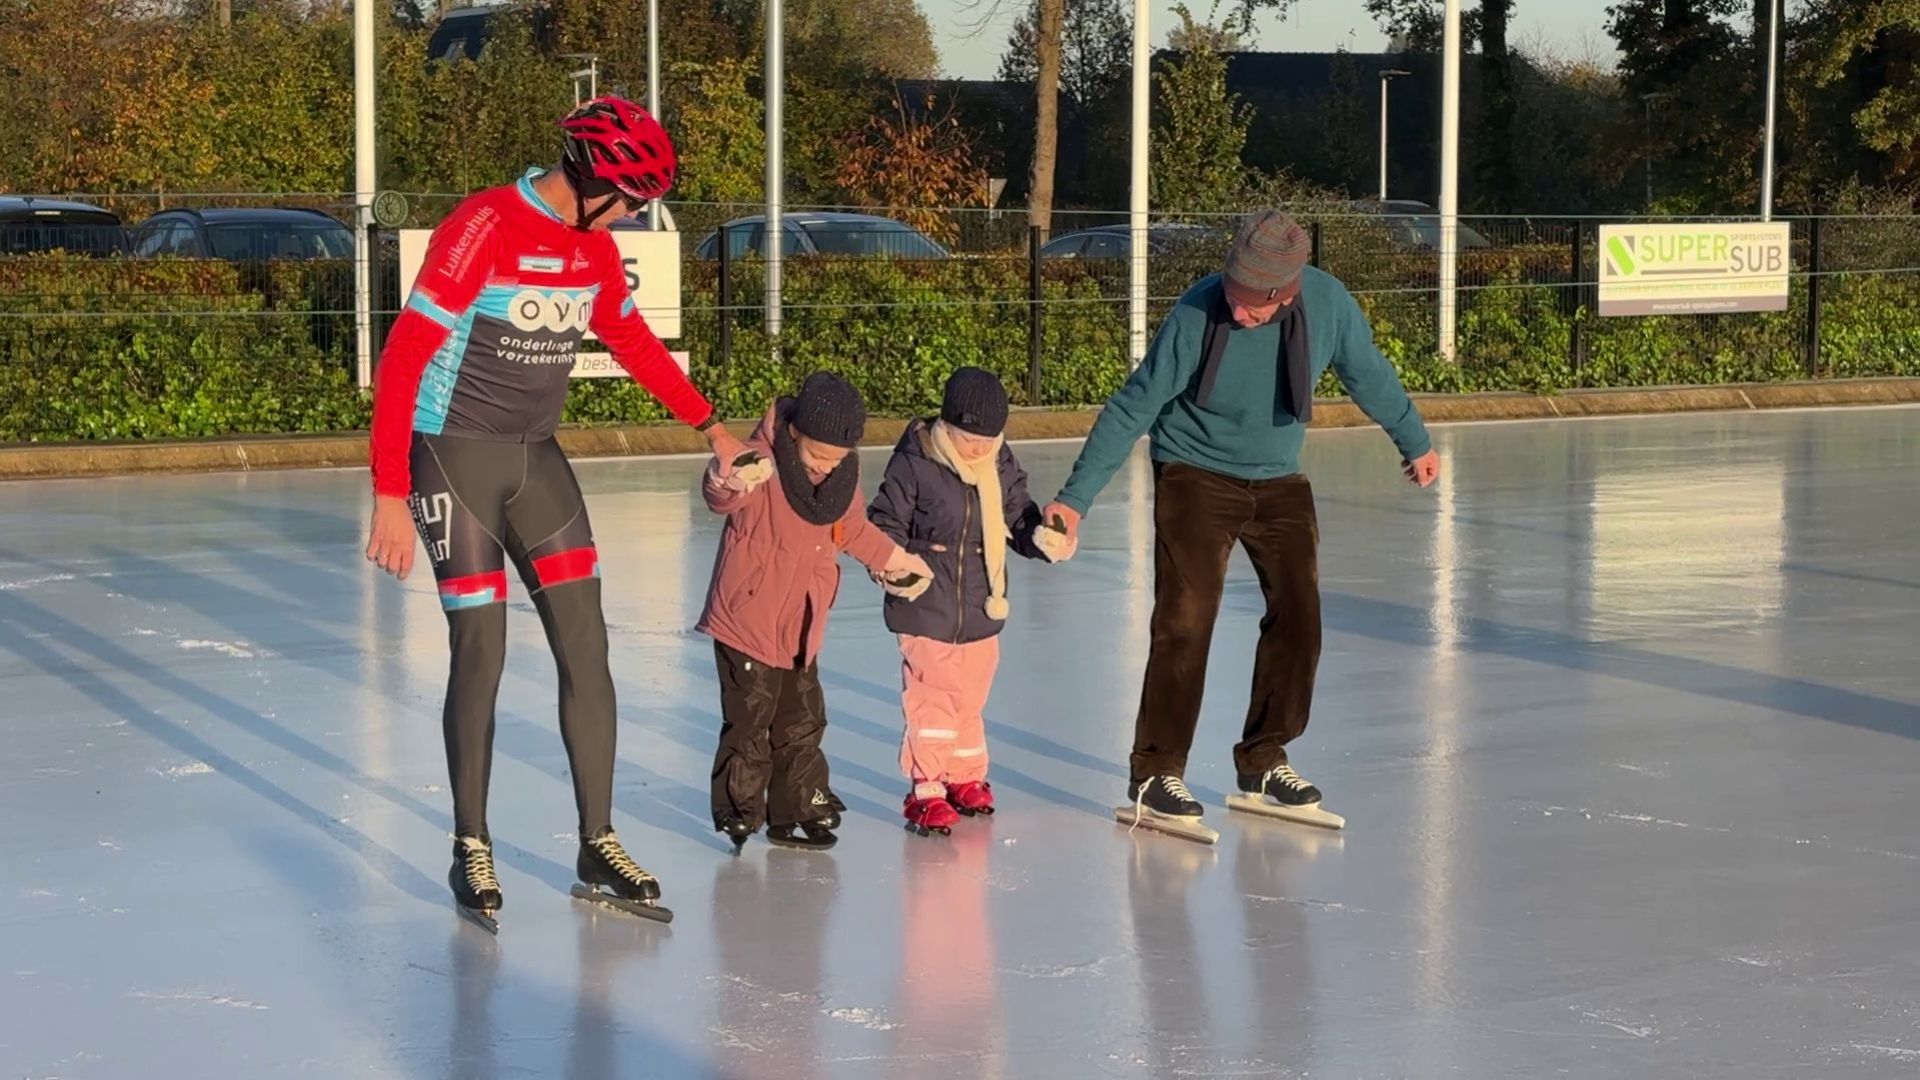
[367,98,744,930]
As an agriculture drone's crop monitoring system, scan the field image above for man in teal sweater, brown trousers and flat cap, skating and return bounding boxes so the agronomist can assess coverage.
[1046,209,1440,822]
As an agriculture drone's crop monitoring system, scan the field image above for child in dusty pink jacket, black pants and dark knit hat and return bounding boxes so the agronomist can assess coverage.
[697,371,931,853]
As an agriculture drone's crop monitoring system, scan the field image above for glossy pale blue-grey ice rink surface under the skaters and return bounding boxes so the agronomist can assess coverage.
[0,409,1920,1080]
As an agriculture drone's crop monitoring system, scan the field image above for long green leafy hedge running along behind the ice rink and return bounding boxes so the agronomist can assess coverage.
[0,258,1920,442]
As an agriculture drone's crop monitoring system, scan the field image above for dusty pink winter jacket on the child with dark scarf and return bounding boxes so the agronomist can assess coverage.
[695,400,895,669]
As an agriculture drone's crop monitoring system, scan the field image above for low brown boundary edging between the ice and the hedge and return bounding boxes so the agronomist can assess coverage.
[0,379,1920,480]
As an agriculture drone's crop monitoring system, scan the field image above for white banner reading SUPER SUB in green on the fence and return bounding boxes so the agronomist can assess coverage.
[1599,221,1793,315]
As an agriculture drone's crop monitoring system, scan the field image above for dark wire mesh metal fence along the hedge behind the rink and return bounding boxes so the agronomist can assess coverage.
[0,194,1920,438]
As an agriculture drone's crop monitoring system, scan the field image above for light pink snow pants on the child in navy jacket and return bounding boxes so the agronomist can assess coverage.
[900,634,1000,794]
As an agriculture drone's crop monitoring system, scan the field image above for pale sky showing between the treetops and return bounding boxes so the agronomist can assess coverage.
[920,0,1613,79]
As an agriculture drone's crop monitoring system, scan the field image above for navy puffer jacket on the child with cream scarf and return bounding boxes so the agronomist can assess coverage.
[866,421,1046,646]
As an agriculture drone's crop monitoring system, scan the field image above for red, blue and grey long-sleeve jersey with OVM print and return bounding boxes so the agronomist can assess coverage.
[371,169,712,496]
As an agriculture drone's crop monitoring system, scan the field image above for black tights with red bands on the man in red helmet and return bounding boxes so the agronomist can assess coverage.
[411,434,614,836]
